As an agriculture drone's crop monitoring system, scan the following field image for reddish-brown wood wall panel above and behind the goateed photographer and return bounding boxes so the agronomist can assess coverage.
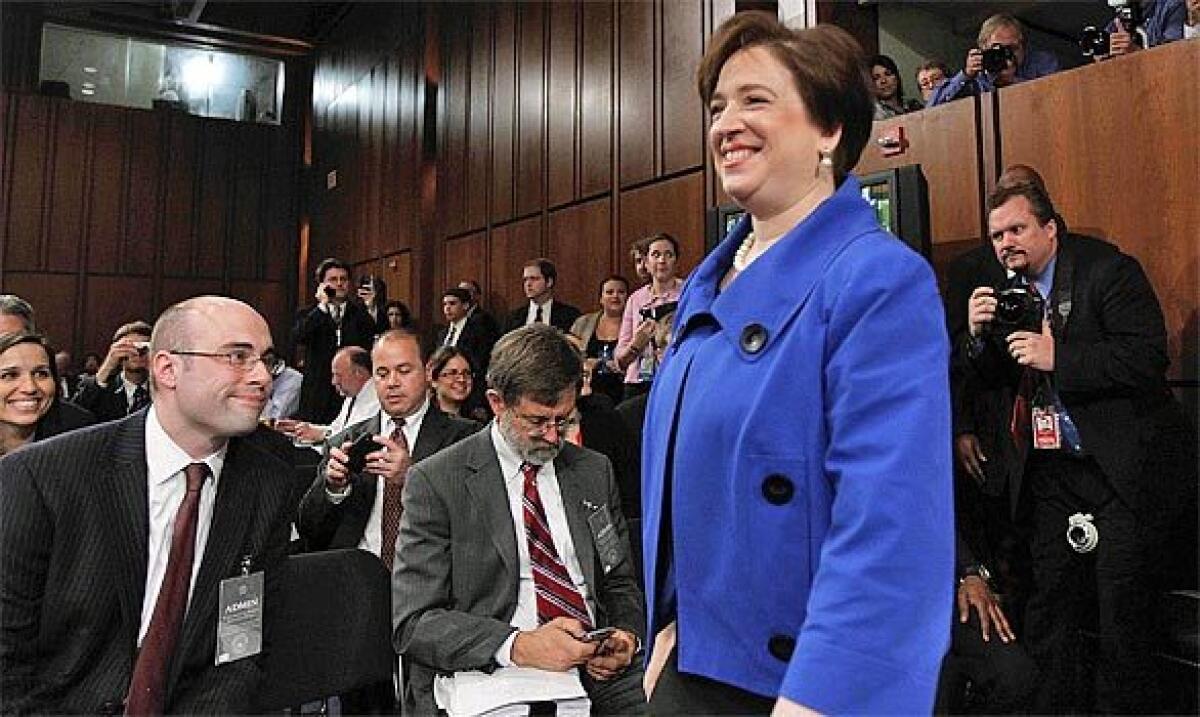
[998,42,1200,385]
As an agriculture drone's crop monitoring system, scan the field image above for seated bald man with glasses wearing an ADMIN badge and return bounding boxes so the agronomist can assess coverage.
[0,296,295,715]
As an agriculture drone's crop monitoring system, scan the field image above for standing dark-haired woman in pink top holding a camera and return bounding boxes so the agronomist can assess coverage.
[616,233,683,398]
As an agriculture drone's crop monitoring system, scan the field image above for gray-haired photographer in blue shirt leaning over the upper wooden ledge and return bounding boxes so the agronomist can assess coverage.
[926,13,1060,107]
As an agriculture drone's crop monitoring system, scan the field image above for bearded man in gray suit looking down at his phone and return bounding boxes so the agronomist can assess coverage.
[392,324,646,715]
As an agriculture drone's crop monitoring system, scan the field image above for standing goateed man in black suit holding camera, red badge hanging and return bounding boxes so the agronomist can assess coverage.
[955,182,1187,713]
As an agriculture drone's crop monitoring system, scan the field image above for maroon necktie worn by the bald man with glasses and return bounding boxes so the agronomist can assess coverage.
[125,463,209,716]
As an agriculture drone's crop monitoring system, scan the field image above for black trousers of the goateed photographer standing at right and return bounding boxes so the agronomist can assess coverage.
[1025,451,1158,715]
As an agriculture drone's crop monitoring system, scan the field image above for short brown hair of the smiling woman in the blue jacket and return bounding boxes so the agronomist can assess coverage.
[696,12,875,183]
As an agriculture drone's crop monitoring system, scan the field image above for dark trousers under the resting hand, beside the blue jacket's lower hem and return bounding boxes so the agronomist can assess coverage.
[934,607,1038,715]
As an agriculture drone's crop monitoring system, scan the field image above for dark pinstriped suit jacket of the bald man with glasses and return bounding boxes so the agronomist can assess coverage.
[0,411,292,715]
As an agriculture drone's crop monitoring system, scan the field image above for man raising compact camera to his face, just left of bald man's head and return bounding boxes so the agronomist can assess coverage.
[74,321,151,422]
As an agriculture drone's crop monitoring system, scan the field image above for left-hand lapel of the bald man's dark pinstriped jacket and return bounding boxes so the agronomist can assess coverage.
[95,414,150,646]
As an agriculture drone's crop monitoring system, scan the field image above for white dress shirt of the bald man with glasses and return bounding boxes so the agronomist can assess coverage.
[138,404,228,645]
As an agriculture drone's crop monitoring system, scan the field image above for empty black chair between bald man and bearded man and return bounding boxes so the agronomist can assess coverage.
[258,549,396,711]
